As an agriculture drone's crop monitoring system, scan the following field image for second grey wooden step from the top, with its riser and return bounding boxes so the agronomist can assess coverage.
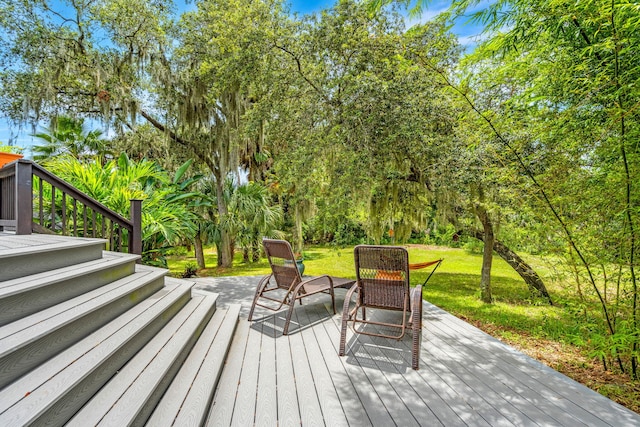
[0,251,140,326]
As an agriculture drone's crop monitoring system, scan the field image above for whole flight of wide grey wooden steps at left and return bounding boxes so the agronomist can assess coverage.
[0,233,240,427]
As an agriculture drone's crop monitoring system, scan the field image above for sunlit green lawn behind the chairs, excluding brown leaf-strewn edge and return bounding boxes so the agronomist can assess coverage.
[168,246,571,339]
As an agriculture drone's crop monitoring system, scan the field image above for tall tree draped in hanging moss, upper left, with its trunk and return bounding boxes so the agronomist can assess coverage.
[0,0,286,266]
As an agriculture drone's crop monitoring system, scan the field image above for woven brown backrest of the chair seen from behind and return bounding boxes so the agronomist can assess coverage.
[354,245,410,310]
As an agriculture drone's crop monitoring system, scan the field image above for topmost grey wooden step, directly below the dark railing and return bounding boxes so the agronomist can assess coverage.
[0,234,105,282]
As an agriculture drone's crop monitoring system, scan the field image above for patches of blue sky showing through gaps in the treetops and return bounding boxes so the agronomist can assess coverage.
[0,0,490,156]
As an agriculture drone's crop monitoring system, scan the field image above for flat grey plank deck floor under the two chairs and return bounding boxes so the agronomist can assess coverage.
[197,277,640,427]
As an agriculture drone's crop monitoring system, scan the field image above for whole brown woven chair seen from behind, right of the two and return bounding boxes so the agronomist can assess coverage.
[339,245,422,369]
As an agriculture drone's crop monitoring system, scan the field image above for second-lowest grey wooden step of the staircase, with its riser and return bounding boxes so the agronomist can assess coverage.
[67,295,224,427]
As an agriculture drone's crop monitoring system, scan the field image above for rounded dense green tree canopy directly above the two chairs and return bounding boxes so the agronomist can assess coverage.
[271,1,457,251]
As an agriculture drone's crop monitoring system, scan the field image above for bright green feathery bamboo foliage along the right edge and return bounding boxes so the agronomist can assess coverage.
[444,0,640,377]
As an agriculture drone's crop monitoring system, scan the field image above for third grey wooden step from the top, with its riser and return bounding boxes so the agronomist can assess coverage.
[0,266,166,388]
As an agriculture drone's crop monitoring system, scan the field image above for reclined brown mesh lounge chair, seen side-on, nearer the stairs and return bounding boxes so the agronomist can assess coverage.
[249,239,340,335]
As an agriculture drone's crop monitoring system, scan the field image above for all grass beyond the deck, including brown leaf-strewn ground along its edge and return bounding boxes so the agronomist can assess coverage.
[168,245,640,412]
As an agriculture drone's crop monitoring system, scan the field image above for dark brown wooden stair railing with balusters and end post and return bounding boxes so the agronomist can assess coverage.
[0,159,142,254]
